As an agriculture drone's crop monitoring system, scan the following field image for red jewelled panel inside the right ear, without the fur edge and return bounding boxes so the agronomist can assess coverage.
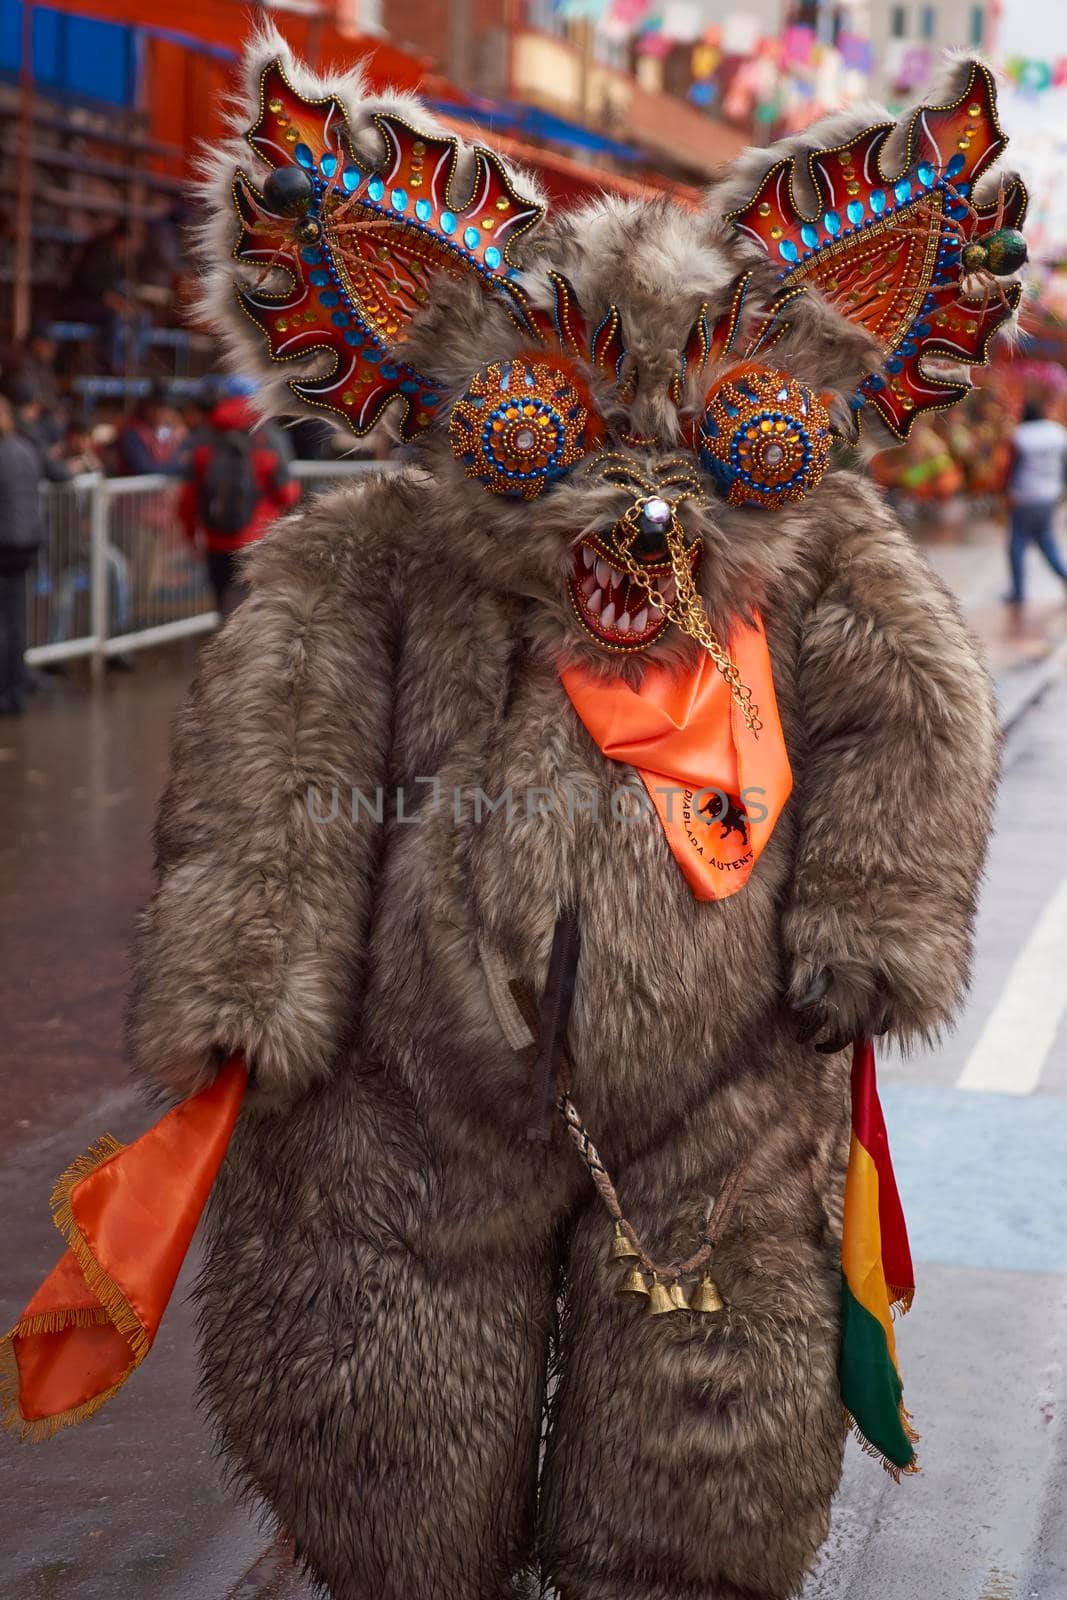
[729,62,1027,438]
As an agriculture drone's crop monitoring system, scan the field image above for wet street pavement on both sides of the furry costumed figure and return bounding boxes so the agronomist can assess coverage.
[0,534,1067,1600]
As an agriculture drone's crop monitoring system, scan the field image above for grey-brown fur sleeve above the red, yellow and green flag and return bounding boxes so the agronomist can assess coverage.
[784,480,1000,1038]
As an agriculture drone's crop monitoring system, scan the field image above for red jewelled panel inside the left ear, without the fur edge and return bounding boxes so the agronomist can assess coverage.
[234,61,542,438]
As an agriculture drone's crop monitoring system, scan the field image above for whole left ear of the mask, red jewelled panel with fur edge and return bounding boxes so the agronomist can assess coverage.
[205,34,544,438]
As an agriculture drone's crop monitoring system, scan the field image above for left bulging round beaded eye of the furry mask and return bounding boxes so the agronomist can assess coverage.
[448,358,601,499]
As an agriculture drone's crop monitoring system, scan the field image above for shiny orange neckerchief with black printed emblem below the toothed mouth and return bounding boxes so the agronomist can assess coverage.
[560,618,793,899]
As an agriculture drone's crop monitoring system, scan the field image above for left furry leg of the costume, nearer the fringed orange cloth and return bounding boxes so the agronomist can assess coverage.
[200,1072,557,1600]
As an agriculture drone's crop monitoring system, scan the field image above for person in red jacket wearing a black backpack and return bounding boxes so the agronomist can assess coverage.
[179,379,299,616]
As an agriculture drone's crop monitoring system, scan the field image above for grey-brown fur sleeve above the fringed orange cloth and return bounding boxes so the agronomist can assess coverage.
[126,467,410,1098]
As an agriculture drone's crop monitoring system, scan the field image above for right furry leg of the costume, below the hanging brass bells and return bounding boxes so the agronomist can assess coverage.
[542,1081,845,1600]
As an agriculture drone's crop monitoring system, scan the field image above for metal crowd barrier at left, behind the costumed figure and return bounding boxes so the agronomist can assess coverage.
[26,461,394,675]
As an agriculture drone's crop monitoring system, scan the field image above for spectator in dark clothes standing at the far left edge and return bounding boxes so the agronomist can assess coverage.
[0,397,42,717]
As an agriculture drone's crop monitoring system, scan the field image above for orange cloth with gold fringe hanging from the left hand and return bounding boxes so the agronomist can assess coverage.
[0,1056,248,1440]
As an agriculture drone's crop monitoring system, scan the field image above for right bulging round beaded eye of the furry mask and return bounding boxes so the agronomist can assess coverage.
[697,365,830,506]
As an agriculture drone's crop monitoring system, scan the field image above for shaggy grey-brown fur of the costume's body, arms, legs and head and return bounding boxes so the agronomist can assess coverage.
[130,37,997,1600]
